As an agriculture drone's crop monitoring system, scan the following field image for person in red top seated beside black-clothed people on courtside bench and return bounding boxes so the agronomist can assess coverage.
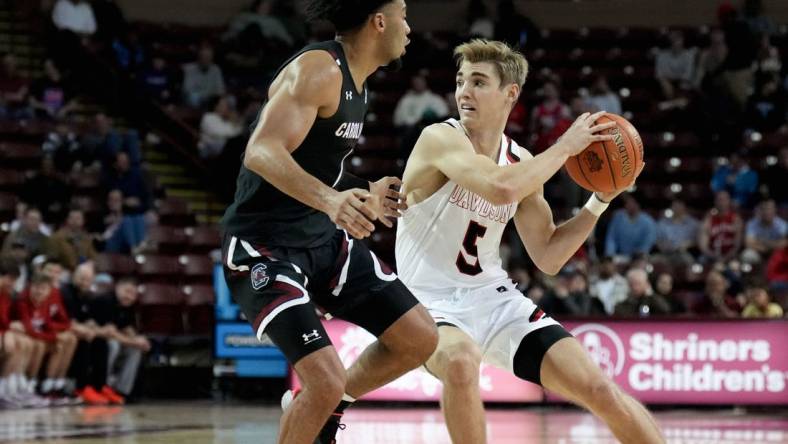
[17,273,77,404]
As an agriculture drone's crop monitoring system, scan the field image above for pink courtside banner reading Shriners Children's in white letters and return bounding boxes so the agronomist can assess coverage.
[548,320,788,405]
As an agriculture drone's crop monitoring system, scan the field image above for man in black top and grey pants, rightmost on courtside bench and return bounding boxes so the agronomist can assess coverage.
[94,278,151,397]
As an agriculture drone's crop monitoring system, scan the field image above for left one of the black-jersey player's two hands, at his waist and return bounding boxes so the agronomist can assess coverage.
[327,188,378,239]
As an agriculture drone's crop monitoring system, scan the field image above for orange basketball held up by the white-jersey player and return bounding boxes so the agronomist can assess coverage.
[565,113,643,193]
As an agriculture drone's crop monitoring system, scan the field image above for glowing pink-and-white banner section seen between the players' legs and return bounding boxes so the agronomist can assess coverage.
[291,319,544,402]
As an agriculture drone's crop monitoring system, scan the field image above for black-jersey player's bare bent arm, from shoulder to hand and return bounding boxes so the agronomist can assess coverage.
[244,51,379,238]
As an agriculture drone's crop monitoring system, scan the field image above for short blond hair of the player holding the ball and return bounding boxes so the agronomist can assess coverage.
[454,39,528,89]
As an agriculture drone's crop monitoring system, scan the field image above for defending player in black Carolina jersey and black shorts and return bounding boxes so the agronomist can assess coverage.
[222,0,437,444]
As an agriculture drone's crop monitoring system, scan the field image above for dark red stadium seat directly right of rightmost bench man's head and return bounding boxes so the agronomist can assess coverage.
[139,283,184,335]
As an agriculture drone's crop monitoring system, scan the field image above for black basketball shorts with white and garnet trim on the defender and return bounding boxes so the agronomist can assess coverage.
[222,230,418,365]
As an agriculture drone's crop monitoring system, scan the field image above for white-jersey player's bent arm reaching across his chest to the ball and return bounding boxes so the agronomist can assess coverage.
[413,112,615,205]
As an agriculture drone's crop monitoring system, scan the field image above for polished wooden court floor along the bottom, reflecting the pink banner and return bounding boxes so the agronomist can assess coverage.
[0,401,788,444]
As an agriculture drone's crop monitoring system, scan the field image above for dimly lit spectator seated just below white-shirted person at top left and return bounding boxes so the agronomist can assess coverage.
[30,59,77,120]
